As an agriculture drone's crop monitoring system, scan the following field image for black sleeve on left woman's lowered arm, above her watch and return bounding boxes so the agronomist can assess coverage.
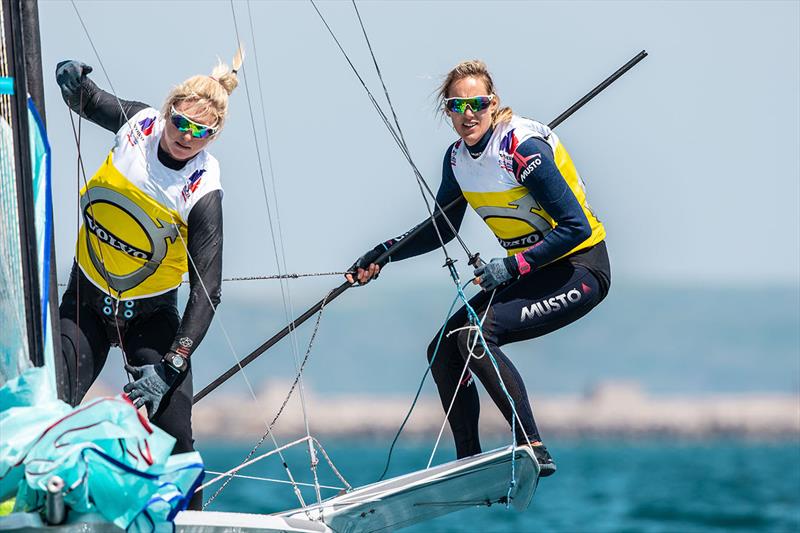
[170,191,222,357]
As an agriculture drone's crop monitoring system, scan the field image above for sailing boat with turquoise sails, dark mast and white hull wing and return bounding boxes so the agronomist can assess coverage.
[0,0,538,532]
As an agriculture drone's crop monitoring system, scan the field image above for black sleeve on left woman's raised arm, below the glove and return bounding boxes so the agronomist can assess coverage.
[62,76,150,133]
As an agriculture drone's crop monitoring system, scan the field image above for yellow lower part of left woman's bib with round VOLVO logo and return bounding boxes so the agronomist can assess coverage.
[77,155,187,298]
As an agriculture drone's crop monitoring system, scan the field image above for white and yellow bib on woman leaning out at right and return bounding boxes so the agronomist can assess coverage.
[450,116,606,256]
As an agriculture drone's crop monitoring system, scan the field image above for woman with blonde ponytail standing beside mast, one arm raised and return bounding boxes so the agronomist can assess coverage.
[56,50,242,508]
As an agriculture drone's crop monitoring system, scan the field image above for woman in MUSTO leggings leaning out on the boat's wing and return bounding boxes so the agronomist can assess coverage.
[348,61,611,476]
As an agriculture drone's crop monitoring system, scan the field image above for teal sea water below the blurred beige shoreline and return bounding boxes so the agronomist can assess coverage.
[200,439,800,533]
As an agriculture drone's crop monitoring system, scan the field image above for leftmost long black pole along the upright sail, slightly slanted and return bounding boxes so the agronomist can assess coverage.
[2,0,44,366]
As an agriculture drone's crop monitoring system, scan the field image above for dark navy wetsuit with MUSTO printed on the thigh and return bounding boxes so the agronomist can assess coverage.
[383,125,611,458]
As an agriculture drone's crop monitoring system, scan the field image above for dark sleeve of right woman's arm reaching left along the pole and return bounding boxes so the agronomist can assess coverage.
[383,146,467,261]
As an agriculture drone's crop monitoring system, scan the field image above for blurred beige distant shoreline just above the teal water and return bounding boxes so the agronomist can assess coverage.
[183,383,800,441]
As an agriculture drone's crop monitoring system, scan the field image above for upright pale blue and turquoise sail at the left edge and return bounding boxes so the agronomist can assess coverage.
[0,2,55,386]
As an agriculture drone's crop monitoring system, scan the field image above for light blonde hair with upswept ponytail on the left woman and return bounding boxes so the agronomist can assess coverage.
[162,45,244,133]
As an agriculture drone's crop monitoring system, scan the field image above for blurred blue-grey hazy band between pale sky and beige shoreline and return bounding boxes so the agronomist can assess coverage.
[89,282,800,402]
